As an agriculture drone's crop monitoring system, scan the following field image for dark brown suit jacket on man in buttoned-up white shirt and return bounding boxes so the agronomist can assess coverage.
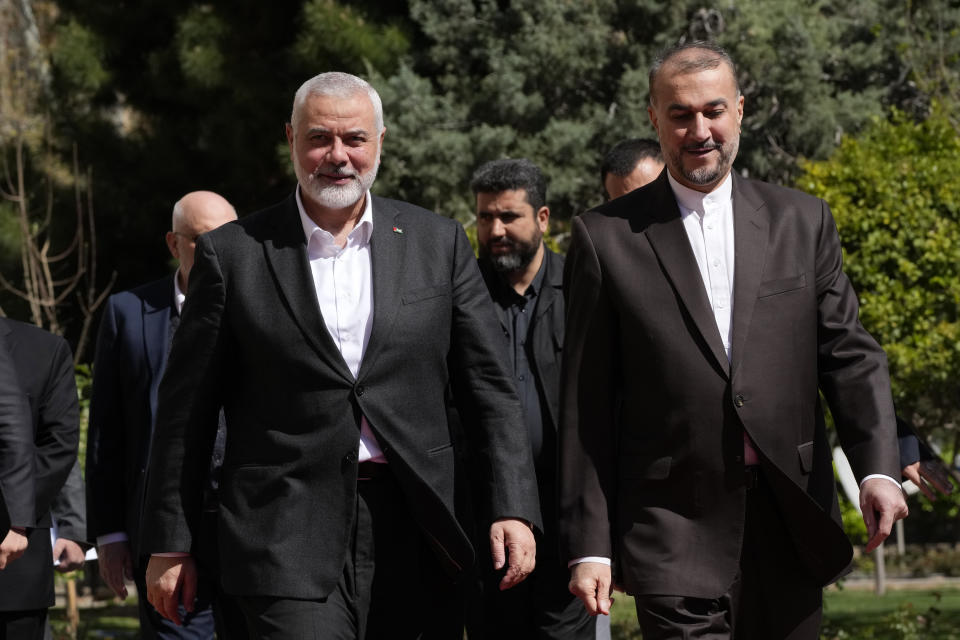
[561,172,899,598]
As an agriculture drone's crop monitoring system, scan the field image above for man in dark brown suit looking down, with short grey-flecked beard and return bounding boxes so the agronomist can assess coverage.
[560,43,907,640]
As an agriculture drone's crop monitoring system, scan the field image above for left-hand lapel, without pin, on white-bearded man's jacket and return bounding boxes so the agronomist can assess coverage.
[263,195,353,383]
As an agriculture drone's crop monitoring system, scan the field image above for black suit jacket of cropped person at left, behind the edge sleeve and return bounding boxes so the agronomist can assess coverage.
[0,318,80,611]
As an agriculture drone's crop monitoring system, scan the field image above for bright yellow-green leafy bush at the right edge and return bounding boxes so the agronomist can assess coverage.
[798,111,960,436]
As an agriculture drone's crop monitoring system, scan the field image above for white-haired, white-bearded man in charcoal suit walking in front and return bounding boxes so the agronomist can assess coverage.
[144,73,539,639]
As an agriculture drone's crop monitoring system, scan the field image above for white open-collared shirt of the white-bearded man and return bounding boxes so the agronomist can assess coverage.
[296,186,387,462]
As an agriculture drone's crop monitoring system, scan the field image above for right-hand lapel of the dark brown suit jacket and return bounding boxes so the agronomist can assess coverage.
[730,175,769,371]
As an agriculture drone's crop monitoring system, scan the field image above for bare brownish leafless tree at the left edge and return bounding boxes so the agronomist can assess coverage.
[0,0,115,359]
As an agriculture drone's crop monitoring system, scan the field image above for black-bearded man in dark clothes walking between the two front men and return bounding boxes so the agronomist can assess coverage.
[469,159,597,640]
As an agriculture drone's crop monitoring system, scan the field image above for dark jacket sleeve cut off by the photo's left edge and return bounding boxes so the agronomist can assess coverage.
[0,332,36,536]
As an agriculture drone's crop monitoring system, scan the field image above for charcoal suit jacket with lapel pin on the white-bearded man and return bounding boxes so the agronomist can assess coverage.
[143,196,539,598]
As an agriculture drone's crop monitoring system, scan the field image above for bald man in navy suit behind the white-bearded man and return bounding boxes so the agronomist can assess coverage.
[86,191,237,638]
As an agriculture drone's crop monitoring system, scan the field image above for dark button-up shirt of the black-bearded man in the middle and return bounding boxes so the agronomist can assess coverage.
[491,256,547,466]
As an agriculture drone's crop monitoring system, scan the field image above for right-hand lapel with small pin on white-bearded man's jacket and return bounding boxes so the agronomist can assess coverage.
[357,196,407,379]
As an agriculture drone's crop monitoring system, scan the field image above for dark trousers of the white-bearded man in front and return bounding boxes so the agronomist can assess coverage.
[236,465,464,640]
